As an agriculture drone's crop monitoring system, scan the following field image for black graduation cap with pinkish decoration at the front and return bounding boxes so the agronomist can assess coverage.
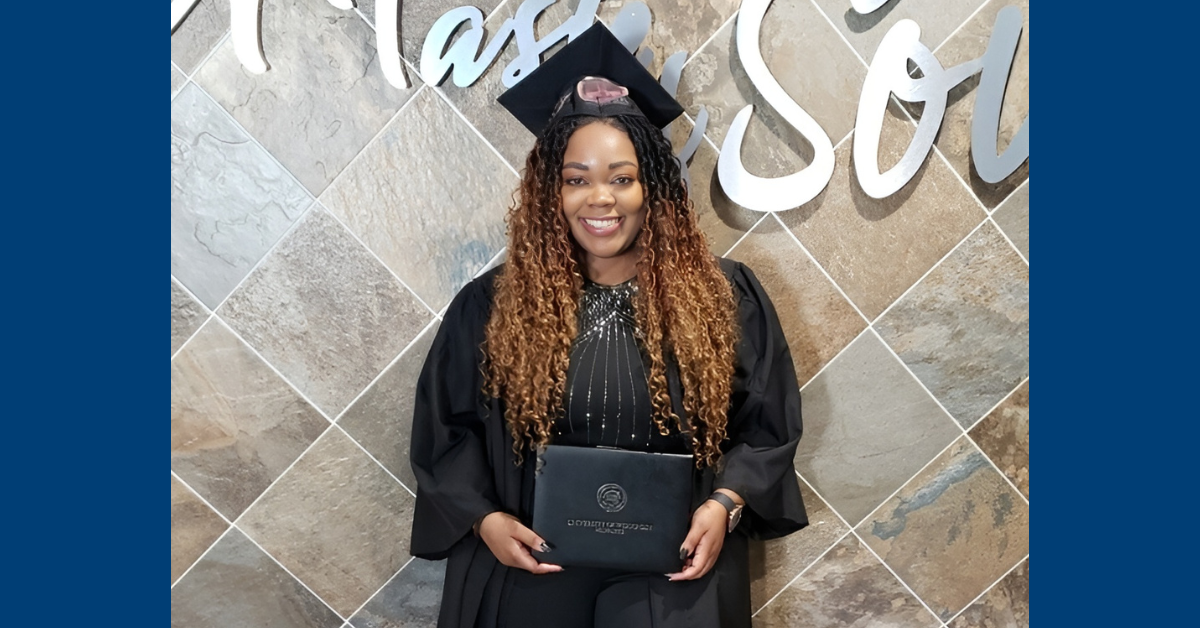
[496,22,683,137]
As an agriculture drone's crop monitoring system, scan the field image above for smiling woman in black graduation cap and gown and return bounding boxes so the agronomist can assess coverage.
[410,24,808,628]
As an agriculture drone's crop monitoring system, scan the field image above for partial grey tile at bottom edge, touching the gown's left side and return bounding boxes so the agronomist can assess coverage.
[350,558,446,628]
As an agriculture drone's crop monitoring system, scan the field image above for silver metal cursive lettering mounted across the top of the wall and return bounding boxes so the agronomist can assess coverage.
[170,0,1030,211]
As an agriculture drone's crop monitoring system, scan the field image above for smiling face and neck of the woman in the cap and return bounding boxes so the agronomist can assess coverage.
[563,121,646,283]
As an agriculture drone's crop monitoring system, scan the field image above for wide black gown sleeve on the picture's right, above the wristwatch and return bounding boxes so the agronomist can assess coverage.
[714,261,808,539]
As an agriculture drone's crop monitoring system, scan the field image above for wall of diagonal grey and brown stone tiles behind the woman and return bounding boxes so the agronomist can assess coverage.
[170,0,1030,628]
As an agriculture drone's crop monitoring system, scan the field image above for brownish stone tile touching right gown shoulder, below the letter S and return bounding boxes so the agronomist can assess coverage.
[728,217,866,387]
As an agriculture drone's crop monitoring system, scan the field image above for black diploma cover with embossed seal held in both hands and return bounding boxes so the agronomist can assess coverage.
[533,445,692,574]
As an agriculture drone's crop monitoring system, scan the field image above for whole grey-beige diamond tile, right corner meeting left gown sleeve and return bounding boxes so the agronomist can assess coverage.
[217,205,432,418]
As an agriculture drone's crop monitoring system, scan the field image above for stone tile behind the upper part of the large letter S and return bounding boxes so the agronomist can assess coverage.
[678,0,866,177]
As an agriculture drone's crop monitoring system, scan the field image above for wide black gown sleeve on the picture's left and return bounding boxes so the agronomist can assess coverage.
[409,280,500,560]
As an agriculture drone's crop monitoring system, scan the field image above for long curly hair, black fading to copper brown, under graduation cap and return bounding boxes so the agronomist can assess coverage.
[485,115,738,467]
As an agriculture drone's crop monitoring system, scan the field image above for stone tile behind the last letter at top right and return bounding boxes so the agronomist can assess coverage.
[936,0,1030,208]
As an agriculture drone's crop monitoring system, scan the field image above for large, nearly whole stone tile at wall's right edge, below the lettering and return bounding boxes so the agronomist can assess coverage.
[876,222,1030,429]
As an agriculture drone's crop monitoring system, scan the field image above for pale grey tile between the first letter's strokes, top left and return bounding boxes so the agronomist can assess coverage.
[192,0,420,195]
